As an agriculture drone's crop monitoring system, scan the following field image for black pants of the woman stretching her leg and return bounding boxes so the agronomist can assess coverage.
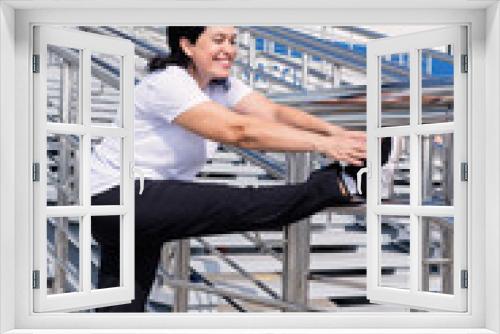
[92,168,349,312]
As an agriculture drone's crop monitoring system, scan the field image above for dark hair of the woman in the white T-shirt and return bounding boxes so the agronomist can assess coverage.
[148,26,206,72]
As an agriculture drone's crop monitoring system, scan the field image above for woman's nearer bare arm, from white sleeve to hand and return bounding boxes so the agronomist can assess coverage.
[174,102,366,164]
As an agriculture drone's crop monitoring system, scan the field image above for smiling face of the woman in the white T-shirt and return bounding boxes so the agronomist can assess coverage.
[181,27,237,80]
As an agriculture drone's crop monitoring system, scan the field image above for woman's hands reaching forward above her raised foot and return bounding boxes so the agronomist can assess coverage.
[317,130,366,166]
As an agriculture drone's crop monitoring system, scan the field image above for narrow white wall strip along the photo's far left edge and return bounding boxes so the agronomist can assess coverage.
[0,3,15,333]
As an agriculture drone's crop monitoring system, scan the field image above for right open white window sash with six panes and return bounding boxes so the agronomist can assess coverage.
[366,26,470,312]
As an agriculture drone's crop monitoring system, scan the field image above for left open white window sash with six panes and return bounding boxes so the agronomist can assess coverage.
[33,26,135,312]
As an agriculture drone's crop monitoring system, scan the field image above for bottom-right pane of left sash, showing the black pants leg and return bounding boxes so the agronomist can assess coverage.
[91,216,121,289]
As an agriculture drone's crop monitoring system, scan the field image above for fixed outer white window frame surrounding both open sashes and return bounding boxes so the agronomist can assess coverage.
[0,0,500,334]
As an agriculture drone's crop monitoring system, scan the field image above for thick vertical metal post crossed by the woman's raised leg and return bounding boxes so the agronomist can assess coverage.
[283,153,311,306]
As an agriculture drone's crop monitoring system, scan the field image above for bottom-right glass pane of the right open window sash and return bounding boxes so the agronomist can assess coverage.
[422,217,453,294]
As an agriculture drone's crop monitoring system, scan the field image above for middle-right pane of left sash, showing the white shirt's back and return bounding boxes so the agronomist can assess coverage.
[90,137,123,205]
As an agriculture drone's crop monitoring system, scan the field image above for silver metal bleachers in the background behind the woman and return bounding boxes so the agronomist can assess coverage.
[48,26,451,312]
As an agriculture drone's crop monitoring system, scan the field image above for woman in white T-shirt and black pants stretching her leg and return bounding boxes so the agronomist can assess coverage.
[92,27,365,312]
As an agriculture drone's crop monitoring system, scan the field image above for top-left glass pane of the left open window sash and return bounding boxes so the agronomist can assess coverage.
[47,45,80,123]
